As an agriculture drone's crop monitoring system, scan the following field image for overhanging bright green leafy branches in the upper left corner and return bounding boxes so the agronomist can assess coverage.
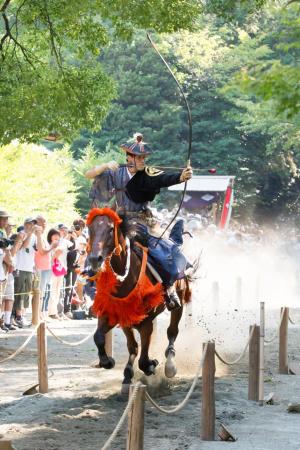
[0,0,201,143]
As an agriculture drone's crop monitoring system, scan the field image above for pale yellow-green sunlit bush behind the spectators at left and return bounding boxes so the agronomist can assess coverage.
[0,141,77,225]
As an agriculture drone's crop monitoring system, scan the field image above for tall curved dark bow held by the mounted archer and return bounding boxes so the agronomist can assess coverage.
[147,33,192,243]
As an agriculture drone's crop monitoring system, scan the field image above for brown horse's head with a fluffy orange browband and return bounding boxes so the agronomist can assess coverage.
[86,208,122,271]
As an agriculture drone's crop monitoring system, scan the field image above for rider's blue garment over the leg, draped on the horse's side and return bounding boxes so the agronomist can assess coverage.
[139,220,187,286]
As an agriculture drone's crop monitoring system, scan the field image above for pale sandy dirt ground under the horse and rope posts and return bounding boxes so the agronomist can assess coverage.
[0,313,300,450]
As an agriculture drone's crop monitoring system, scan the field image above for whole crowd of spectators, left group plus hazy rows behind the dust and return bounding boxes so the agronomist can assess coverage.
[0,204,300,332]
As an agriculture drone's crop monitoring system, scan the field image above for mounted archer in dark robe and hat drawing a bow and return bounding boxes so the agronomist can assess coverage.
[85,133,193,309]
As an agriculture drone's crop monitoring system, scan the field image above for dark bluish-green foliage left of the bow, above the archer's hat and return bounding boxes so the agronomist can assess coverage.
[71,35,186,165]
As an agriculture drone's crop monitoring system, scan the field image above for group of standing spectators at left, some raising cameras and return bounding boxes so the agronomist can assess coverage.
[0,210,87,333]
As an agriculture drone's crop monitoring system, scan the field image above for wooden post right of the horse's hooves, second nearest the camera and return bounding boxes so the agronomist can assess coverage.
[201,342,216,441]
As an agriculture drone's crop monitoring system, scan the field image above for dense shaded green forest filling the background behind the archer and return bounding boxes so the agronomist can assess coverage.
[0,2,300,229]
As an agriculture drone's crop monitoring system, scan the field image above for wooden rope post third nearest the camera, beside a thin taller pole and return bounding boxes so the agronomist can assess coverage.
[248,325,260,402]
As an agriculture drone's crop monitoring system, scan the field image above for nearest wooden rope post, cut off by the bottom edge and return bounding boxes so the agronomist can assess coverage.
[126,385,146,450]
